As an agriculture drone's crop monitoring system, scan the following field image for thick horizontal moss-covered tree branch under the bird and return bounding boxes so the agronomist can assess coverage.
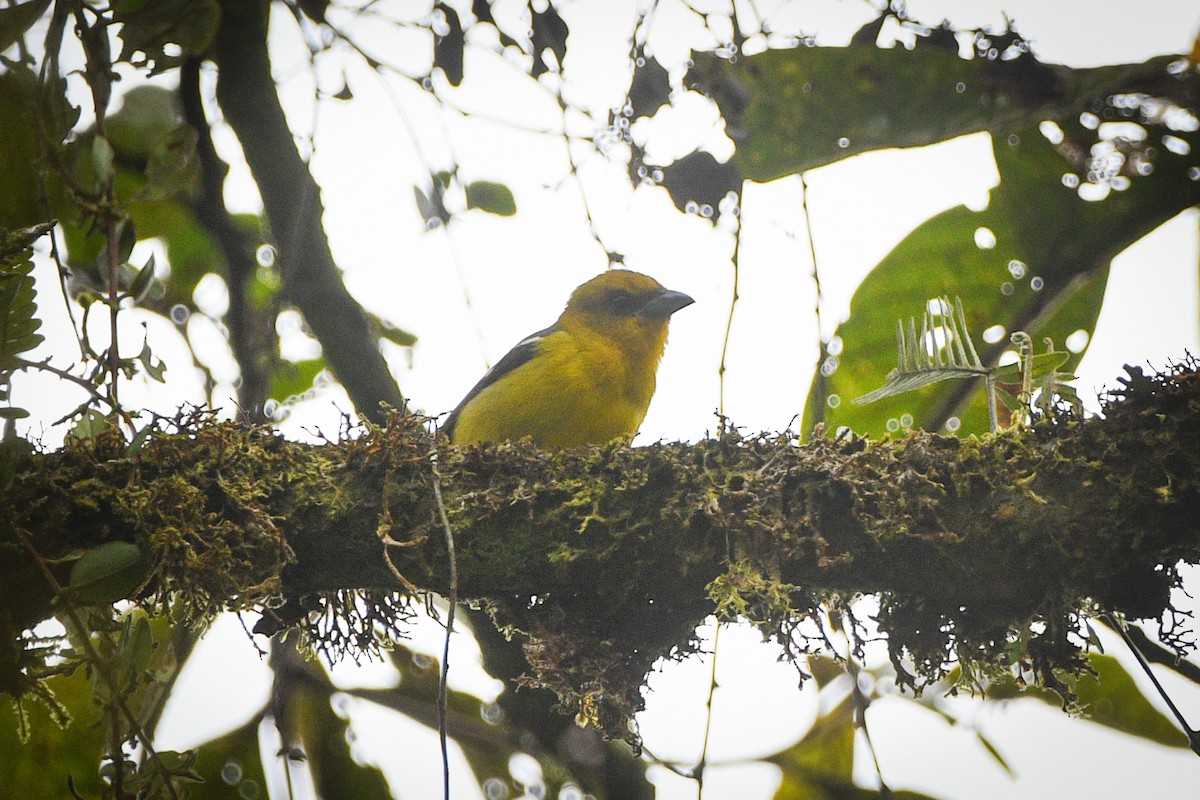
[0,360,1200,734]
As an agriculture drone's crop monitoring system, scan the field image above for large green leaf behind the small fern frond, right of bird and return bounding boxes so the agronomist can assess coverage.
[805,120,1200,435]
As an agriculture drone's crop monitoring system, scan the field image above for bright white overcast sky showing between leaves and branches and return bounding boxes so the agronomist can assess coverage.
[14,0,1200,800]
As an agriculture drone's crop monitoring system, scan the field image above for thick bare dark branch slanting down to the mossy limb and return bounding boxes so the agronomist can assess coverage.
[214,0,404,421]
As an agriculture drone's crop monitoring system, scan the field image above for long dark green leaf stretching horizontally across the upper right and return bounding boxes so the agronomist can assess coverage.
[686,29,1195,181]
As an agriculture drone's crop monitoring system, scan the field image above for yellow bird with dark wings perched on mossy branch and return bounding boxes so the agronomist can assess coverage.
[442,270,695,447]
